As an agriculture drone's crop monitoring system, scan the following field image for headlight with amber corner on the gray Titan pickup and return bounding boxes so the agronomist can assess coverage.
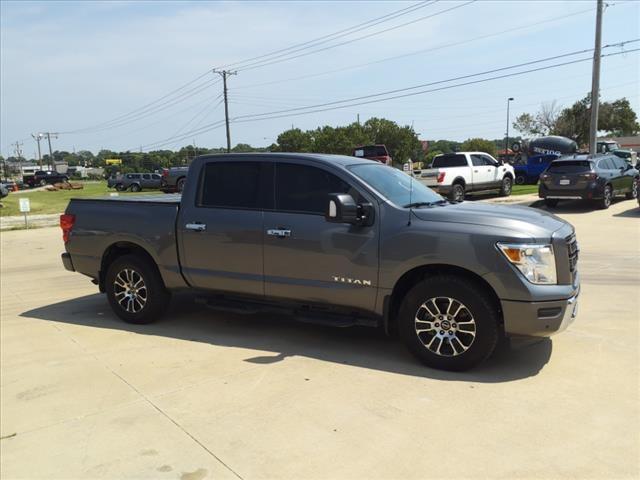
[498,243,558,285]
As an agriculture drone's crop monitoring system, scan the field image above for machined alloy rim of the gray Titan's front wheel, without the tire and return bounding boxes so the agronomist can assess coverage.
[415,297,476,357]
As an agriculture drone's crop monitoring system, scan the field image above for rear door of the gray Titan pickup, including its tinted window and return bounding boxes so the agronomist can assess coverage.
[177,157,273,295]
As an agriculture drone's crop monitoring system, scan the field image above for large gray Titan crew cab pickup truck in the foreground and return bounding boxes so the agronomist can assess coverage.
[60,153,580,370]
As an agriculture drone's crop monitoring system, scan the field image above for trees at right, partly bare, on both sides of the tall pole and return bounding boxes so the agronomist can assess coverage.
[513,94,640,146]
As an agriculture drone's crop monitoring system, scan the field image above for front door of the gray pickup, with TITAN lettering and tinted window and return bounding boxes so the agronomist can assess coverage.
[264,160,379,310]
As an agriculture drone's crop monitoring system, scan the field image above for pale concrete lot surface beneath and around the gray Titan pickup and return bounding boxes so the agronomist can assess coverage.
[0,201,640,480]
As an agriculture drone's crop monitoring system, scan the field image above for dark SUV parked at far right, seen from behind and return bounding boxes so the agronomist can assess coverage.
[538,154,639,208]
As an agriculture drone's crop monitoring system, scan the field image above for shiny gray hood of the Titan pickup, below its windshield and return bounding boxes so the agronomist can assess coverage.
[413,202,567,238]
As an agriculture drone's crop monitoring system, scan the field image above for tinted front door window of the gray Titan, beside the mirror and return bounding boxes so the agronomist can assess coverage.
[276,163,362,215]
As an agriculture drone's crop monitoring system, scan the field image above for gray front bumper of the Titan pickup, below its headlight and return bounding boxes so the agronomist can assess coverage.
[502,292,579,337]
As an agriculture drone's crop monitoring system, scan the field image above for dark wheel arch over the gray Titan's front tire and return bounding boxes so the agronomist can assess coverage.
[383,264,504,332]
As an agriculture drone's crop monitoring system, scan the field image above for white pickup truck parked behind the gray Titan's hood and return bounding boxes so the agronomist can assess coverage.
[421,152,515,202]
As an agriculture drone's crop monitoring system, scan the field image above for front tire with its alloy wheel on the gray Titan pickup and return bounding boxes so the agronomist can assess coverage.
[398,275,499,371]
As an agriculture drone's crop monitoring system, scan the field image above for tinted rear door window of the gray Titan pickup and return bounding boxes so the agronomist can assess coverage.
[198,161,261,209]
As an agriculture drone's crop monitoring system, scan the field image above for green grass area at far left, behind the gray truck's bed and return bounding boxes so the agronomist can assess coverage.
[0,181,158,217]
